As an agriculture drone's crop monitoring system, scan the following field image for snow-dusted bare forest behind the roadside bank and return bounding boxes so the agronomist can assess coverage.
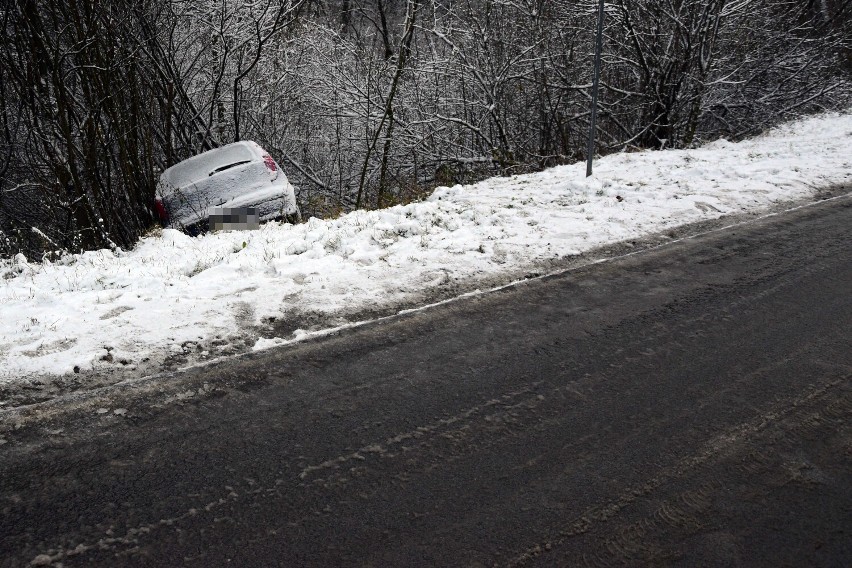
[0,0,852,258]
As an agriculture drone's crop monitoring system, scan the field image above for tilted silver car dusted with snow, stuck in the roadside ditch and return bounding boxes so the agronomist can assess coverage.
[155,141,300,234]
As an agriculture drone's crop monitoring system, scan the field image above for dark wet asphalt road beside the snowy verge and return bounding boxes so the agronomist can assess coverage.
[0,197,852,567]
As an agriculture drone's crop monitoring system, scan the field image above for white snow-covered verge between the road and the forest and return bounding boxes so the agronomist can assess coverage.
[0,114,852,385]
